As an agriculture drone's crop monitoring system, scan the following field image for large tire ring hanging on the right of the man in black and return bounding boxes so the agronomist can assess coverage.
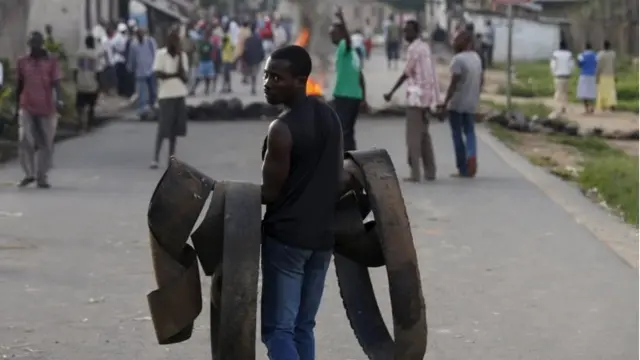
[334,149,427,360]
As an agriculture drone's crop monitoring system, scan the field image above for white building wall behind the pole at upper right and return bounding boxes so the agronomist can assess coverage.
[470,14,560,62]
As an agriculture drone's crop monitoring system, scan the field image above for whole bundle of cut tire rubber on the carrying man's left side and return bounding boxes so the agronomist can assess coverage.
[147,159,261,360]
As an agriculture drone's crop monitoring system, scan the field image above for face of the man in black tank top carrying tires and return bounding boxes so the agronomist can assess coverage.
[264,58,299,105]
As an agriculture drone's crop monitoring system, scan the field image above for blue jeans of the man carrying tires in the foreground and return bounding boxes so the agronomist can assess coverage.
[261,238,332,360]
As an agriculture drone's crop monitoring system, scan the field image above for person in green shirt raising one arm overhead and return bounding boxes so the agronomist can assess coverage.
[331,10,366,151]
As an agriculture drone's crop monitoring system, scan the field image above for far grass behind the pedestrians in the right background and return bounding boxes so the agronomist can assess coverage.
[496,59,638,112]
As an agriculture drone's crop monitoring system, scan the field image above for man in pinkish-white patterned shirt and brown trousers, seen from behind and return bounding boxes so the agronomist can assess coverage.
[384,20,440,182]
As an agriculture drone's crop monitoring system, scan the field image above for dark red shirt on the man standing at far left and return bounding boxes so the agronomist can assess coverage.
[17,55,60,116]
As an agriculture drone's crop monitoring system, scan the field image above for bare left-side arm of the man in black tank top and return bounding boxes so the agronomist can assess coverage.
[262,120,292,204]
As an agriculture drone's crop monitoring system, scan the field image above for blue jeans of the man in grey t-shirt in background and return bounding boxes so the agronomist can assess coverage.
[449,111,476,175]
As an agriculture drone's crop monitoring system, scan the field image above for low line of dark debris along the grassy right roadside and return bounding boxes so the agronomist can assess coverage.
[483,110,638,140]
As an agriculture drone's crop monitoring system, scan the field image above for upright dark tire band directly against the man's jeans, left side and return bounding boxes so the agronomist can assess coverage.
[211,182,262,360]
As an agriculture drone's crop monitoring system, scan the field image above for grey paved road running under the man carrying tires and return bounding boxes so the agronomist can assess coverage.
[0,112,638,360]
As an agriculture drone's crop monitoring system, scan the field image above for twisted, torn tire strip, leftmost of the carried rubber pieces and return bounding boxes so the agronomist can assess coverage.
[147,159,214,344]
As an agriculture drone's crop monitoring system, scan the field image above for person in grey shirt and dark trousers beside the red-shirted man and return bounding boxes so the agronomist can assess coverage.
[73,35,100,132]
